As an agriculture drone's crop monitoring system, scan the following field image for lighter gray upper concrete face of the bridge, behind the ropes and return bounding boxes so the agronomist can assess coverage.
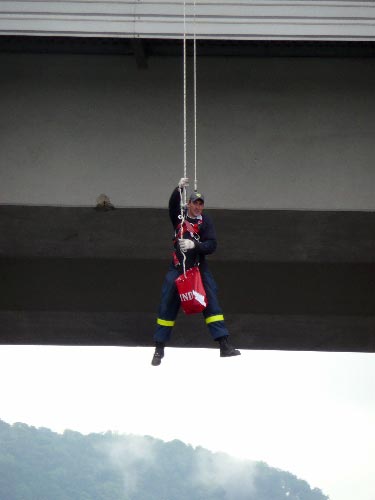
[0,54,375,210]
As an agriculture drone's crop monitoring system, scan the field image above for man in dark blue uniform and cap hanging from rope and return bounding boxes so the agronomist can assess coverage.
[151,177,241,366]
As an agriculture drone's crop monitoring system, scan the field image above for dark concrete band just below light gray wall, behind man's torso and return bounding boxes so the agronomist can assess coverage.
[0,205,375,263]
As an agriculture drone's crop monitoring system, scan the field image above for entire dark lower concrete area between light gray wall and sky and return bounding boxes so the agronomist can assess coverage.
[0,206,375,352]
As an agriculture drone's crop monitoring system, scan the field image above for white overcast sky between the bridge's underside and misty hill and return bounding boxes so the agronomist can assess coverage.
[0,346,375,500]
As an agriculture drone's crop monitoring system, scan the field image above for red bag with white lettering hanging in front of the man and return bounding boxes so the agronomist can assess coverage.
[175,266,207,314]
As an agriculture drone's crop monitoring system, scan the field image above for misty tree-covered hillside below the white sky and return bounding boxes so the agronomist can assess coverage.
[0,420,329,500]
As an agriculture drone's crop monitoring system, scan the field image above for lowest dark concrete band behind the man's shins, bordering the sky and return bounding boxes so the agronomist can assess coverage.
[0,311,375,352]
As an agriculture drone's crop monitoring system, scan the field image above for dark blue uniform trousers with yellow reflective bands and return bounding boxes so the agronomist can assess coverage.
[154,264,229,343]
